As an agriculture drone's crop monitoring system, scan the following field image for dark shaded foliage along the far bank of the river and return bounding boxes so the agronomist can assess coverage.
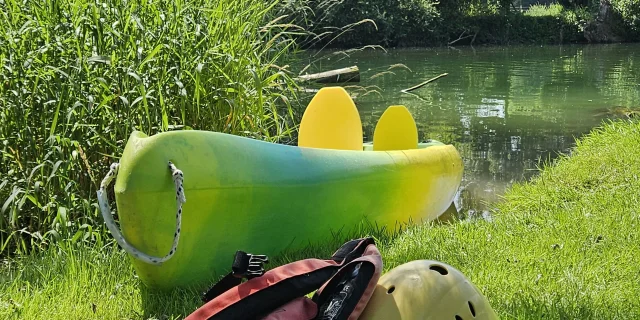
[286,0,640,47]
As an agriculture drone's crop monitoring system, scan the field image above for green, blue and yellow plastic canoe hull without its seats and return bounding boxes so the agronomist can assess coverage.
[114,130,463,289]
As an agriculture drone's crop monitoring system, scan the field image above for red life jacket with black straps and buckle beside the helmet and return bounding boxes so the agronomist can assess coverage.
[185,238,382,320]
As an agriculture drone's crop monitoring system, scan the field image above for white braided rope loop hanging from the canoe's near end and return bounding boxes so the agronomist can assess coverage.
[98,161,187,265]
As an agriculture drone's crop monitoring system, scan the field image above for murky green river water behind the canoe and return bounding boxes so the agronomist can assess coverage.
[298,44,640,217]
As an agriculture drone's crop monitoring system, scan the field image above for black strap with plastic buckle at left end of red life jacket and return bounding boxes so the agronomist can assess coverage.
[202,250,269,303]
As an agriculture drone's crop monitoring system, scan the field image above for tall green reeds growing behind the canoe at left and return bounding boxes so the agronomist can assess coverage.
[0,0,302,254]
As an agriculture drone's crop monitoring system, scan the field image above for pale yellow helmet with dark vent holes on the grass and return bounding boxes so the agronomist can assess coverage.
[358,260,499,320]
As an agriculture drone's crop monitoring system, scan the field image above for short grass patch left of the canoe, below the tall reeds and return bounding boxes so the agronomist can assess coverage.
[0,242,198,319]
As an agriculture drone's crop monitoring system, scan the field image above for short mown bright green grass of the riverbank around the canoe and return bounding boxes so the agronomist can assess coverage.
[0,121,640,319]
